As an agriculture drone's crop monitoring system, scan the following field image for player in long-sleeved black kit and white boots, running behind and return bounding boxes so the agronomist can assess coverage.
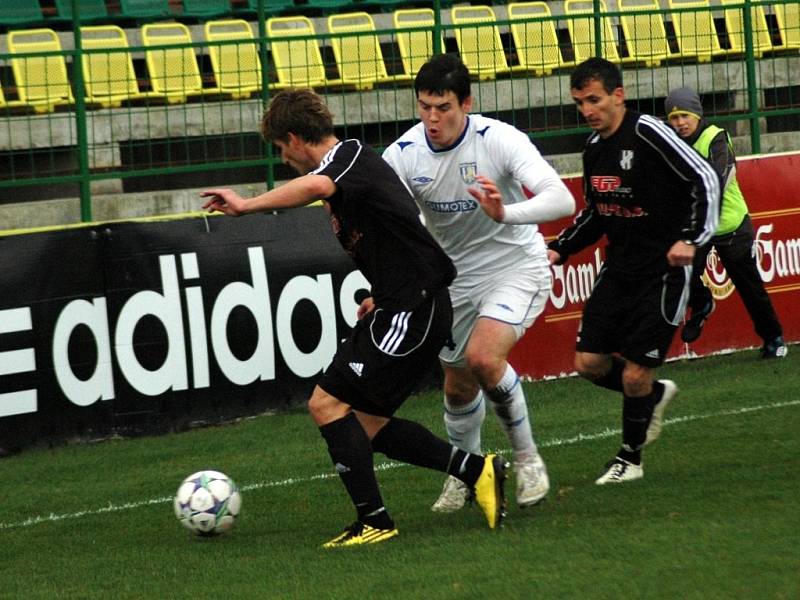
[548,58,720,485]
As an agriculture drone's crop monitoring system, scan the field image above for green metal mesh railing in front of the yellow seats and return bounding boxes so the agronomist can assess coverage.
[0,0,800,221]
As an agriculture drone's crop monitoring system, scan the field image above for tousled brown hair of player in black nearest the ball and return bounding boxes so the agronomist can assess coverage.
[261,88,333,144]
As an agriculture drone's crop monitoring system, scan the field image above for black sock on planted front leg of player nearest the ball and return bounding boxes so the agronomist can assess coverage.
[319,413,394,529]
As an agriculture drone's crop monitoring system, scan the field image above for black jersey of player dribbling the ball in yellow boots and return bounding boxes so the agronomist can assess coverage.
[314,139,456,310]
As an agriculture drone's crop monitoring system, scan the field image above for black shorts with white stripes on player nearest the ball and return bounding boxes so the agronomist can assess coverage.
[319,288,453,417]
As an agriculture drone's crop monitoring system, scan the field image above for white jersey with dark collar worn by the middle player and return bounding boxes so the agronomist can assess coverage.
[383,114,574,284]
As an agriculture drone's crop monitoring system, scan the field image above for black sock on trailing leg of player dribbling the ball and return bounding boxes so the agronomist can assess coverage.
[372,417,484,486]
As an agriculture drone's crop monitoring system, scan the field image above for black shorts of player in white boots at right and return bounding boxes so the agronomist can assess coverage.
[576,267,692,368]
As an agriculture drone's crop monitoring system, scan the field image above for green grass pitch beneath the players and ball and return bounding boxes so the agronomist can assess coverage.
[0,346,800,600]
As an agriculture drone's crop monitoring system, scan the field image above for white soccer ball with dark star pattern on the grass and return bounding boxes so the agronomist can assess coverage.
[174,471,242,536]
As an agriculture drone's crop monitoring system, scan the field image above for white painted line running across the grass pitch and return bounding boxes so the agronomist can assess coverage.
[0,400,800,531]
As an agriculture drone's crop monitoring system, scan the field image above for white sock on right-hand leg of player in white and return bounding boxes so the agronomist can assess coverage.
[486,365,537,460]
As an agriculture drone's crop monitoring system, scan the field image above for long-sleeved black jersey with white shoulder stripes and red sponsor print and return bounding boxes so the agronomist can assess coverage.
[549,109,720,276]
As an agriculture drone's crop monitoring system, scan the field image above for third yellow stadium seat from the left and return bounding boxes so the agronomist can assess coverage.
[141,22,222,103]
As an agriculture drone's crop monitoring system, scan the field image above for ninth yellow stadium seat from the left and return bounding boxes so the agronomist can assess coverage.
[508,2,573,75]
